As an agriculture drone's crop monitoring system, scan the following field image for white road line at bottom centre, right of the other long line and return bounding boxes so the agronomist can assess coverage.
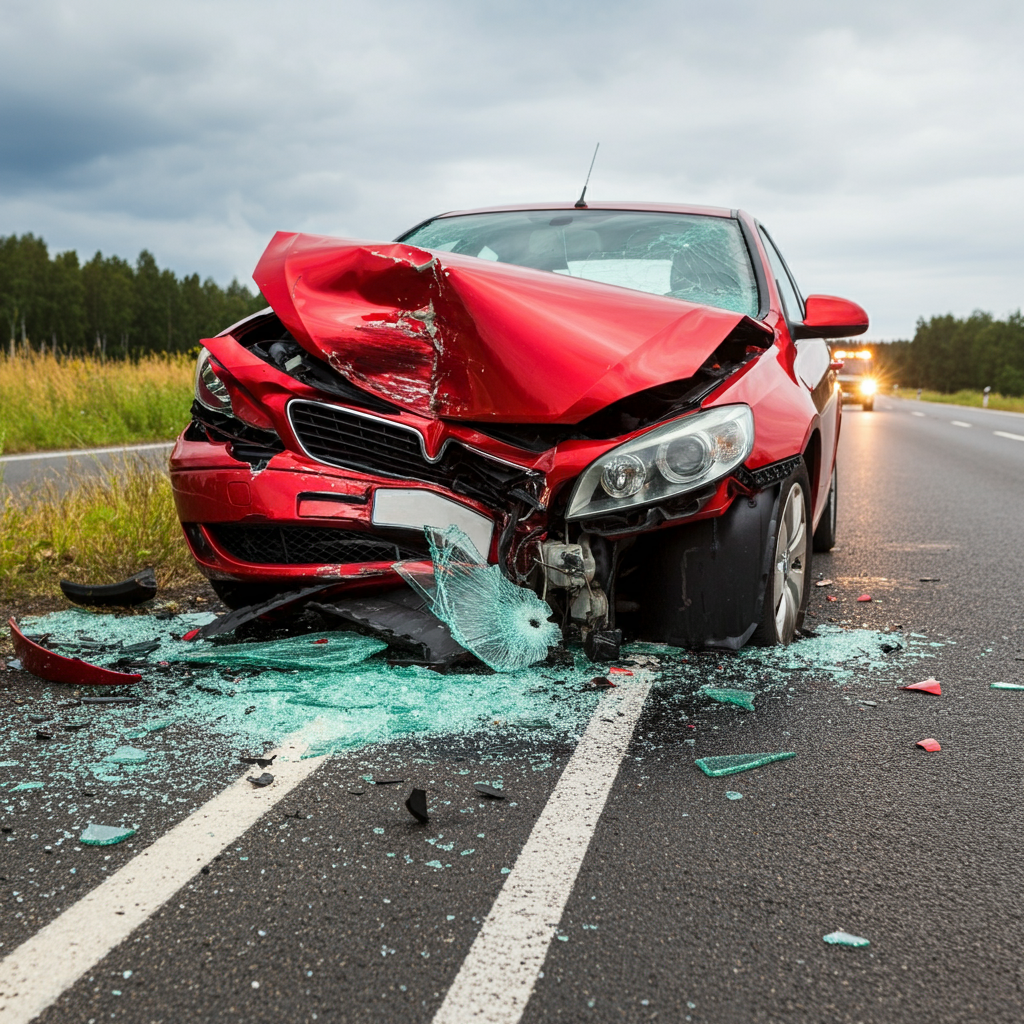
[433,679,650,1024]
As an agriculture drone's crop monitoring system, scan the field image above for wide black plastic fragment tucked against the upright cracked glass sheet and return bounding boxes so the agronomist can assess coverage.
[309,587,473,670]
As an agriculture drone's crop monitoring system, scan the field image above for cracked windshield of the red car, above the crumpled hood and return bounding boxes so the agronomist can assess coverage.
[401,210,758,316]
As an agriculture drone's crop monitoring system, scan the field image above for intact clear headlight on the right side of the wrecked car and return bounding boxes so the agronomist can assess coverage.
[565,406,754,519]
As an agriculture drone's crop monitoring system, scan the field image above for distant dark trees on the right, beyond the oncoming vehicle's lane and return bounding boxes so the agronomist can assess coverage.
[872,310,1024,396]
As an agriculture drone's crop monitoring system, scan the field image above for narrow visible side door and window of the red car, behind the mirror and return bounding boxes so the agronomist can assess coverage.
[758,224,842,528]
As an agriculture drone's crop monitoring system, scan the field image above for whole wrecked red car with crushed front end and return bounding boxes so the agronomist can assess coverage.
[171,203,867,648]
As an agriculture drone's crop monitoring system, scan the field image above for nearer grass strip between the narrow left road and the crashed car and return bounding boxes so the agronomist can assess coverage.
[0,460,203,600]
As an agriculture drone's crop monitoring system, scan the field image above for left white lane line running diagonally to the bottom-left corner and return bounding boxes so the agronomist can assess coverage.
[0,734,325,1024]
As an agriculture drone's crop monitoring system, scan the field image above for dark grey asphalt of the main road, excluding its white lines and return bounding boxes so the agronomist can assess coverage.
[0,398,1024,1024]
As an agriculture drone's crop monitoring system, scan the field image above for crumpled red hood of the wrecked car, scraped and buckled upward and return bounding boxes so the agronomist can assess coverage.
[253,231,766,424]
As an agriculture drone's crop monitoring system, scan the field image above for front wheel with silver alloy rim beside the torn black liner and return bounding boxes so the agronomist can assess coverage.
[753,465,811,646]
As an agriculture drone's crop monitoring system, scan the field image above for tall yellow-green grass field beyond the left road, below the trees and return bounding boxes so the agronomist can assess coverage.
[0,347,196,454]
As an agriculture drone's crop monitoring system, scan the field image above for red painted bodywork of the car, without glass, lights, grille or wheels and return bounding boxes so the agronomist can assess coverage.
[170,203,867,626]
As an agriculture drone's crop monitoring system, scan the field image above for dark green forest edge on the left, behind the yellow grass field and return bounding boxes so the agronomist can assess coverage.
[0,234,266,358]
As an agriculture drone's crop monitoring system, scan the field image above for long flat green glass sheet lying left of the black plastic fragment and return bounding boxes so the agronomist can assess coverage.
[171,632,387,671]
